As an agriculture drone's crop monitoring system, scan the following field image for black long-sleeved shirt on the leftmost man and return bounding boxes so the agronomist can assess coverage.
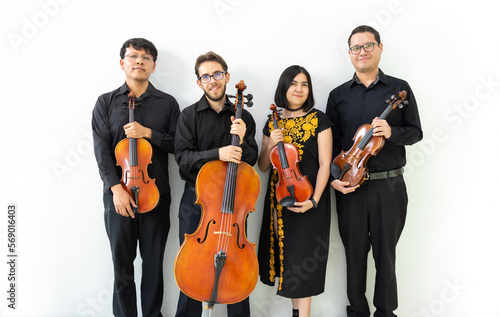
[92,83,180,194]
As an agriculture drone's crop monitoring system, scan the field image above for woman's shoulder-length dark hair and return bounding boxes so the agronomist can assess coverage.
[274,65,314,111]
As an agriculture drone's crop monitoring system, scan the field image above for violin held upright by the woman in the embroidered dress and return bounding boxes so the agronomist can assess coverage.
[269,105,313,207]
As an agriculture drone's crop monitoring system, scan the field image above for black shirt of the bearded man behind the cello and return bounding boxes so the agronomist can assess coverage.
[175,95,258,186]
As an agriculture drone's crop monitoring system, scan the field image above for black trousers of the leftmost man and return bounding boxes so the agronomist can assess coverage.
[104,193,171,317]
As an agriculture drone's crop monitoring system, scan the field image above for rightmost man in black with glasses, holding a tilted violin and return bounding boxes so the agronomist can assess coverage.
[326,25,422,317]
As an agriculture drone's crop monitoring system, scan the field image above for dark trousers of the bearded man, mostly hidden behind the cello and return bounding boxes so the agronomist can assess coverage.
[175,186,250,317]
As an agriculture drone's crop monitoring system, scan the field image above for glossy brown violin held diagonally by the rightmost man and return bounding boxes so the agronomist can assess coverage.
[330,90,408,187]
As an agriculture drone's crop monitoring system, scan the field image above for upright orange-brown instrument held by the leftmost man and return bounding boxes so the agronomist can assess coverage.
[115,92,160,214]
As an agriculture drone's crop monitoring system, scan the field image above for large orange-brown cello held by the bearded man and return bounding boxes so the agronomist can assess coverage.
[174,81,260,313]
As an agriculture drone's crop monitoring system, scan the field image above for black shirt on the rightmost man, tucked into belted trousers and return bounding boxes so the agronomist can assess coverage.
[326,70,423,172]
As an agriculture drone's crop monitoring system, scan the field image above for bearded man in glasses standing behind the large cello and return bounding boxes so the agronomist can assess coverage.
[175,52,258,317]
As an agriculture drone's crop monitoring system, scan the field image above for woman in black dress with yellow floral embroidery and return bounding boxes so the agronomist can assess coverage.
[258,65,332,317]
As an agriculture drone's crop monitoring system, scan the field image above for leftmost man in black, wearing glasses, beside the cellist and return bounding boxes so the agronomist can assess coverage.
[92,38,180,317]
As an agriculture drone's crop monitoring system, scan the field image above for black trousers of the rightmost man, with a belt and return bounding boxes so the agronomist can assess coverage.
[335,176,408,317]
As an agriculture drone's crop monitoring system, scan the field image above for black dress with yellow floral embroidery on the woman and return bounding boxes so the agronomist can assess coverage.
[258,109,332,298]
